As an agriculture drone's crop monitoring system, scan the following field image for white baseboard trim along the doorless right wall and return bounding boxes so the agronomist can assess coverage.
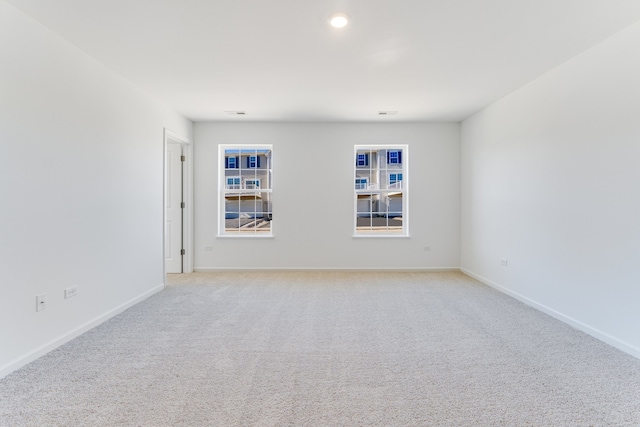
[460,268,640,359]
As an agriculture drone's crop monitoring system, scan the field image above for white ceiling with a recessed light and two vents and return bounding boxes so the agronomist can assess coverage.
[9,0,640,121]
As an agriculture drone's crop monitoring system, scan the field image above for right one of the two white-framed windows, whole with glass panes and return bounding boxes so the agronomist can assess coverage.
[354,145,409,236]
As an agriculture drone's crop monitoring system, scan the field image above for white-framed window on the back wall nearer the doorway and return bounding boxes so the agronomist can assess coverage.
[218,145,273,236]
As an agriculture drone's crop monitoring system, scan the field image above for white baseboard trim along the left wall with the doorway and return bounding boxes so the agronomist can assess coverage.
[0,283,165,378]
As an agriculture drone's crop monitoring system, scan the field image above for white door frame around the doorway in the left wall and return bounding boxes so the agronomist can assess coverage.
[162,128,193,282]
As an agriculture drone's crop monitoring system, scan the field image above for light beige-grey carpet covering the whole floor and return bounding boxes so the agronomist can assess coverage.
[0,272,640,427]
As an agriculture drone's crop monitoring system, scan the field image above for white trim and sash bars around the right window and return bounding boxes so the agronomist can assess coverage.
[352,144,411,239]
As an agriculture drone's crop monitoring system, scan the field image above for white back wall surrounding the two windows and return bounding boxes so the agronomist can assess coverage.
[194,122,460,270]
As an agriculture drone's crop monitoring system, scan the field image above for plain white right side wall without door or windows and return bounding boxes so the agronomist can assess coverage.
[461,23,640,357]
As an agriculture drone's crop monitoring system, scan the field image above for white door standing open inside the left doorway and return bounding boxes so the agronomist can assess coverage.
[164,142,183,273]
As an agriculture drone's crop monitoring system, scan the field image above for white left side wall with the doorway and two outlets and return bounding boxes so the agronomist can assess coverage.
[0,0,192,377]
